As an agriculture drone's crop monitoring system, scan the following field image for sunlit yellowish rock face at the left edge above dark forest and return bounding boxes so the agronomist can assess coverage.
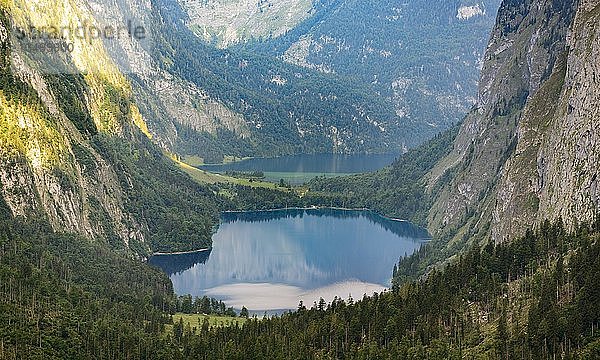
[0,53,145,250]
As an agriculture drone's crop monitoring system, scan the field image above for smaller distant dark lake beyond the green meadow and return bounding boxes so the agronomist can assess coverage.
[199,154,398,184]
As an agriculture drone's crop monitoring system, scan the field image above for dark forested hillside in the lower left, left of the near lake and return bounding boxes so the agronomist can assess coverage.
[0,204,177,360]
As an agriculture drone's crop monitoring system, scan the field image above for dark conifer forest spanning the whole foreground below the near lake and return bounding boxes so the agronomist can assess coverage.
[0,187,600,359]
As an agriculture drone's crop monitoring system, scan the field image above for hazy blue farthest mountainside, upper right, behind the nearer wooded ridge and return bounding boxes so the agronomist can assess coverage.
[242,0,499,146]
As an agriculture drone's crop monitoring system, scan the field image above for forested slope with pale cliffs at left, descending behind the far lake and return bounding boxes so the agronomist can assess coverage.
[81,0,412,162]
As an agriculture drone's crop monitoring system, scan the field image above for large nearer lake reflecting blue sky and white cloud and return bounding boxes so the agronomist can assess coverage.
[150,209,428,311]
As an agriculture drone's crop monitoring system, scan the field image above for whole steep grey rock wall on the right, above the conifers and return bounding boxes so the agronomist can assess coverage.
[430,0,599,246]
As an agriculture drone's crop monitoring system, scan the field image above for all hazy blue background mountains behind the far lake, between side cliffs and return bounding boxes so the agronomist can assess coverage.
[145,0,499,161]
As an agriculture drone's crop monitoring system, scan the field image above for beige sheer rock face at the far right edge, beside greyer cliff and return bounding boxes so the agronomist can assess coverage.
[537,1,600,228]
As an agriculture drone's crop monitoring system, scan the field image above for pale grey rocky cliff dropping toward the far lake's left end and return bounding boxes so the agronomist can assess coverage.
[86,0,249,162]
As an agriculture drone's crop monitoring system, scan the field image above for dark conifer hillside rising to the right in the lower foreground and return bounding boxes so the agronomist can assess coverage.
[144,222,600,360]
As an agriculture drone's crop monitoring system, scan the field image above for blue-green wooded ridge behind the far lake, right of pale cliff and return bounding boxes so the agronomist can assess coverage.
[154,0,412,160]
